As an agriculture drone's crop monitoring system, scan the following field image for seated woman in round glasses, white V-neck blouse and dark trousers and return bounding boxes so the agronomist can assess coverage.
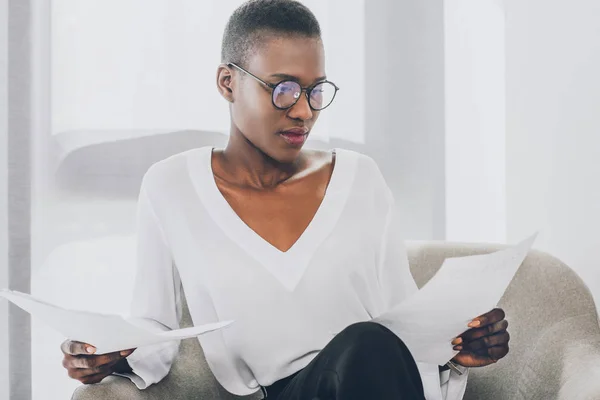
[62,0,509,400]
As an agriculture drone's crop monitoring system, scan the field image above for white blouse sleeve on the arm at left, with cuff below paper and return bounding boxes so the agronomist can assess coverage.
[115,180,182,389]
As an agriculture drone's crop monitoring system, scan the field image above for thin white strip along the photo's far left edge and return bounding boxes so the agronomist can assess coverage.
[0,0,10,399]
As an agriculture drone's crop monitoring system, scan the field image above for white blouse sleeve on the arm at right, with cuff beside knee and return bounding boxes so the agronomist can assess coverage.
[376,160,468,400]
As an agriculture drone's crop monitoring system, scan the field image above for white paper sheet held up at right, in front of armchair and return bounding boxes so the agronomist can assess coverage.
[373,233,537,365]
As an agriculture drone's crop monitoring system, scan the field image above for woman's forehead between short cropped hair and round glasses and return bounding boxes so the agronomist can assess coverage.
[248,36,325,83]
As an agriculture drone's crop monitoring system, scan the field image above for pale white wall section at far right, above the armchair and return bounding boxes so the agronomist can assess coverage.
[507,0,600,301]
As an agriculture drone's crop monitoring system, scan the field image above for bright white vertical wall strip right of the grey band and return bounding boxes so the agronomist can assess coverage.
[444,0,506,243]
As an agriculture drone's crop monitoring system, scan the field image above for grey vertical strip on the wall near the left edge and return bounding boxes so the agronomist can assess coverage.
[7,0,32,400]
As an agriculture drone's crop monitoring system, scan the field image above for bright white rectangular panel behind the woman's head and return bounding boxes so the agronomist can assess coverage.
[51,0,365,142]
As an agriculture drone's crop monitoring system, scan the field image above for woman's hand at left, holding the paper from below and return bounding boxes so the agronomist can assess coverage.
[60,340,135,385]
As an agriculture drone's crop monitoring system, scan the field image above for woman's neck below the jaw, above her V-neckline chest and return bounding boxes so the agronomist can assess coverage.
[218,132,304,189]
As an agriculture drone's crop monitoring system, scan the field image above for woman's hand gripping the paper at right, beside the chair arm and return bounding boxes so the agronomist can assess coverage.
[452,308,510,367]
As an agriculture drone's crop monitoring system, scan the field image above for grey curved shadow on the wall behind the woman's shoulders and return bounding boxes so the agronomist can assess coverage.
[54,130,364,199]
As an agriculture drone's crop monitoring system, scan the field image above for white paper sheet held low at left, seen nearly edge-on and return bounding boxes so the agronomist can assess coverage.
[0,289,233,354]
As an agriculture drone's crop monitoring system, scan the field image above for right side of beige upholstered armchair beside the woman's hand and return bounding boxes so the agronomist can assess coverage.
[407,241,600,400]
